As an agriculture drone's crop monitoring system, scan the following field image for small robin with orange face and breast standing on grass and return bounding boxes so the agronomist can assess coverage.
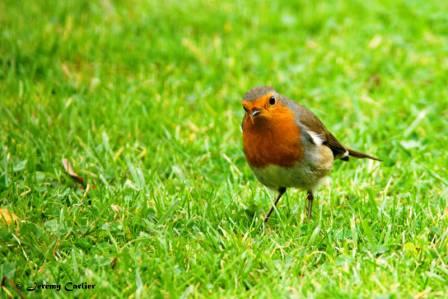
[242,86,381,222]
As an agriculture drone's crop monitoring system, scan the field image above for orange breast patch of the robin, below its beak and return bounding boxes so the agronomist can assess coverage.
[242,107,304,168]
